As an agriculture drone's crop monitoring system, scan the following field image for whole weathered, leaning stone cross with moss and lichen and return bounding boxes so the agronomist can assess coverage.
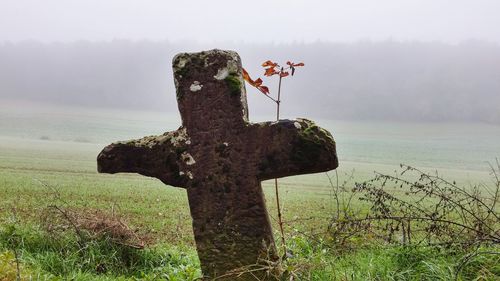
[97,50,338,280]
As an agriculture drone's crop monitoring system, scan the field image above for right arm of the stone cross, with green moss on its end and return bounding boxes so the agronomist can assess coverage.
[255,119,339,180]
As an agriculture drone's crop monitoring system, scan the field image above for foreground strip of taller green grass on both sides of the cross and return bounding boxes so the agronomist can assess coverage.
[0,224,500,280]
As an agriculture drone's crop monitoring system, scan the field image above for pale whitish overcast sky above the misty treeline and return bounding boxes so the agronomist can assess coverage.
[0,0,500,43]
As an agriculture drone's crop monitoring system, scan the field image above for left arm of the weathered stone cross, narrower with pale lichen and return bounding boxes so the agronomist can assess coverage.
[97,129,190,187]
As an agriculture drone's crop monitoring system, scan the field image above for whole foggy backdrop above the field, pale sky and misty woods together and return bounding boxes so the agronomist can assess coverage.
[0,0,500,124]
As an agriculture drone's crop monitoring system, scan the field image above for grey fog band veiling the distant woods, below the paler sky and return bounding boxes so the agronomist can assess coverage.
[0,40,500,124]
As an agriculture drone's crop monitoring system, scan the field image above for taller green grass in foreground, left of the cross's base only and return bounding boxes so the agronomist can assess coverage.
[0,220,201,280]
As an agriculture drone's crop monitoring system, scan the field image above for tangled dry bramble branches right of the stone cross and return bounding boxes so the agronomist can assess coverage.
[327,161,500,250]
